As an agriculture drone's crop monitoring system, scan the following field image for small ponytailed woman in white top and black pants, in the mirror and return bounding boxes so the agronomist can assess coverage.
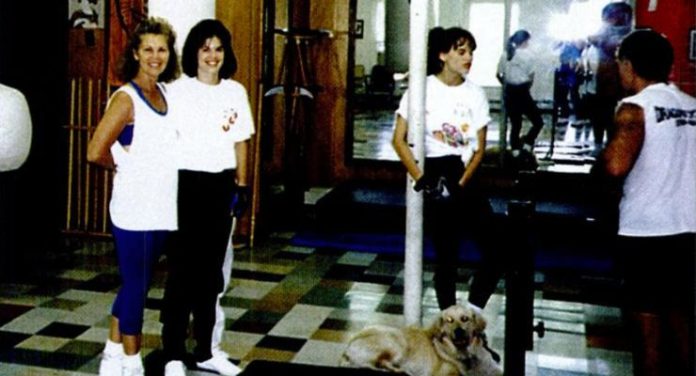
[496,30,544,157]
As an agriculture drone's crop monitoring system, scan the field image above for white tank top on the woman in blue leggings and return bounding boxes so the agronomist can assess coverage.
[109,84,178,231]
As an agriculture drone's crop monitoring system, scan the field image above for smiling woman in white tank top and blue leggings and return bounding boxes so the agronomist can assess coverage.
[87,18,179,376]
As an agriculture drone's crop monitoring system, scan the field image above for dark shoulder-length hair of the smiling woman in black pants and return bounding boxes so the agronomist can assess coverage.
[181,19,237,78]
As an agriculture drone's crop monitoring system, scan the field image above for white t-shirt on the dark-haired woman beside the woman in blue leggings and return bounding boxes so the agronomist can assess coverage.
[167,76,254,173]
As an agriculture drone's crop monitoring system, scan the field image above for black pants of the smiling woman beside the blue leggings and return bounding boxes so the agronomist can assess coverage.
[160,170,235,362]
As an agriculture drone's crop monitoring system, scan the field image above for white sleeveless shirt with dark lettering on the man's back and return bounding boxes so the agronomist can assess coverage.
[619,83,696,236]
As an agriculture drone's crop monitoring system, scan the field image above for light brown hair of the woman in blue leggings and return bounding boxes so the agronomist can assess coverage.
[119,17,179,82]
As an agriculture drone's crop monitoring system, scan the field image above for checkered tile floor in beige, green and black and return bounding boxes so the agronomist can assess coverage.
[0,233,632,376]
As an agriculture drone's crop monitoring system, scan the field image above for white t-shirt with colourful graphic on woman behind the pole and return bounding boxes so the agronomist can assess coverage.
[396,75,491,163]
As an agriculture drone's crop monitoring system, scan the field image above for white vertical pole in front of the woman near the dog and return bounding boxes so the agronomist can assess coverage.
[404,0,428,325]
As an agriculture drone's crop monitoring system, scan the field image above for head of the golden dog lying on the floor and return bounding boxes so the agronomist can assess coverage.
[433,305,486,351]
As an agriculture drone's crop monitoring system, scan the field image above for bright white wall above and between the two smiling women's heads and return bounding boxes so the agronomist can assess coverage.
[148,0,215,56]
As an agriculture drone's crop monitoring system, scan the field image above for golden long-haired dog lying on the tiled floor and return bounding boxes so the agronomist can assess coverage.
[341,305,503,376]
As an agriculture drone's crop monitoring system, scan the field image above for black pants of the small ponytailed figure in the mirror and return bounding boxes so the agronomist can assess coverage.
[505,84,544,149]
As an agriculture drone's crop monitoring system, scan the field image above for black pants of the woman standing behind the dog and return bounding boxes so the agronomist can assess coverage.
[424,156,504,309]
